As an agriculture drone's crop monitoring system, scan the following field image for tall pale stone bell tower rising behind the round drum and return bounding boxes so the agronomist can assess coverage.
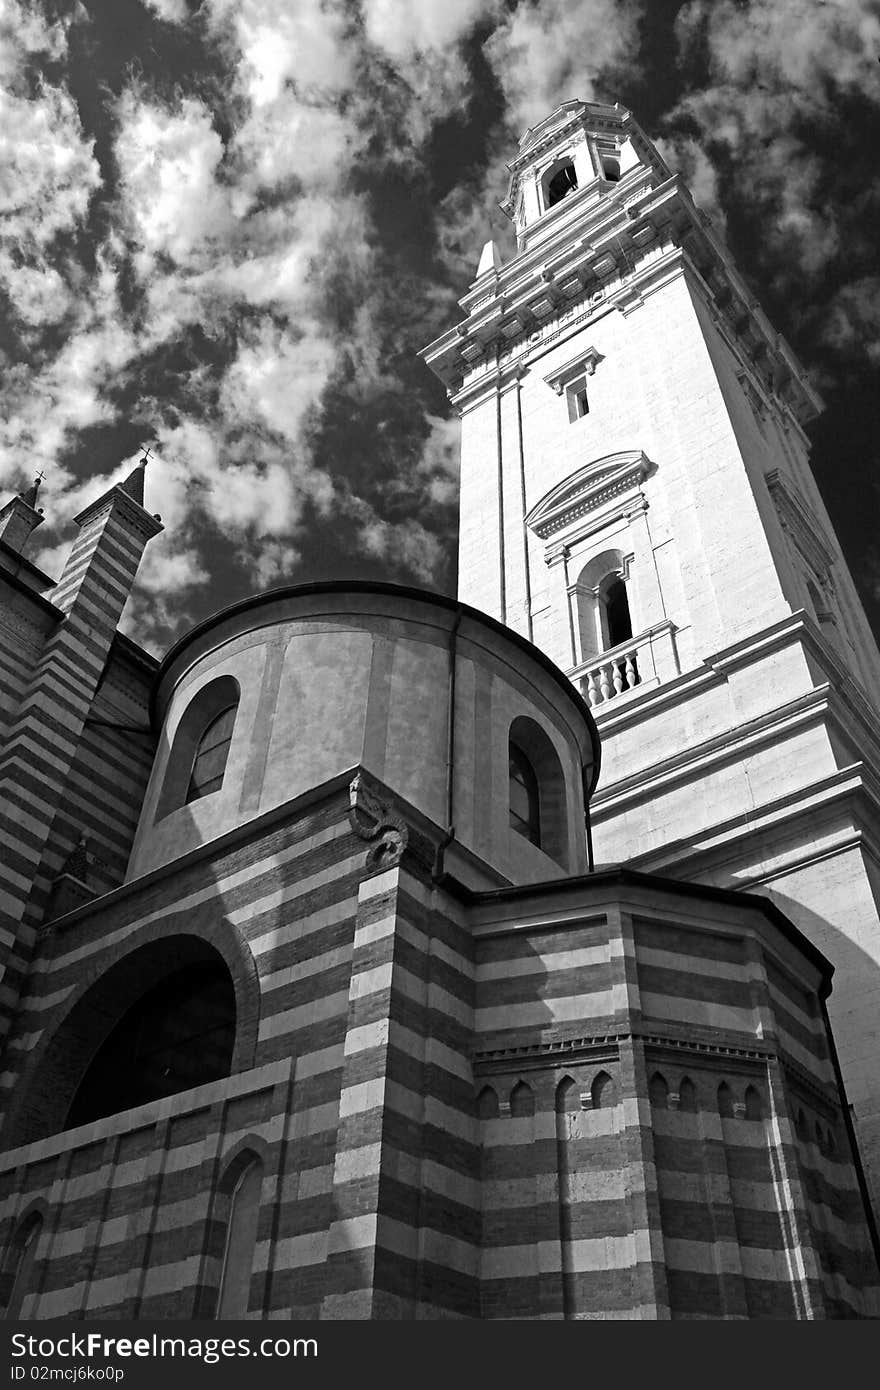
[423,101,880,1200]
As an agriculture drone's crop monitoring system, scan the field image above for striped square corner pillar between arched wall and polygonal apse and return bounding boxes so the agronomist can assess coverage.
[323,869,480,1318]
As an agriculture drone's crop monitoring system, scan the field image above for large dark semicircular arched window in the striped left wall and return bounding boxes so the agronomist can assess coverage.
[65,963,235,1129]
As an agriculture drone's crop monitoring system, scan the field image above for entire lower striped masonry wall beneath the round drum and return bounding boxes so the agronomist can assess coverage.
[0,778,877,1319]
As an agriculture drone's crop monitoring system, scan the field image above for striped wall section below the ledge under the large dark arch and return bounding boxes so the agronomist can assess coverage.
[0,1061,291,1319]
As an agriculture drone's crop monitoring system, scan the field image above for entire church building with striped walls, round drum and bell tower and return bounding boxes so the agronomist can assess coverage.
[0,101,880,1321]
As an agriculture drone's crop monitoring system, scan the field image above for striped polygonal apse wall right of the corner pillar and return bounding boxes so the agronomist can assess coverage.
[475,894,877,1318]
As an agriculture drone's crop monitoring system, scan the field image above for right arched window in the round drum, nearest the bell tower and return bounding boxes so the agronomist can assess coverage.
[507,716,569,869]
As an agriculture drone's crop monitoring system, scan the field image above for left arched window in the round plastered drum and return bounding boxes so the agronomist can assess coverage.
[156,676,241,820]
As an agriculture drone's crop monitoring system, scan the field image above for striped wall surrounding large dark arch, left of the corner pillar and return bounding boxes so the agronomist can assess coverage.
[0,792,364,1318]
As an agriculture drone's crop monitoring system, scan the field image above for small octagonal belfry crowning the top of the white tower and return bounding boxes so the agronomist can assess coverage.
[500,101,670,250]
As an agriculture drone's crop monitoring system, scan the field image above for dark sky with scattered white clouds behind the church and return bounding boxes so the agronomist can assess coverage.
[0,0,880,651]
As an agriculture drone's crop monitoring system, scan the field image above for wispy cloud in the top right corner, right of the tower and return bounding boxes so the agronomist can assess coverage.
[669,0,880,288]
